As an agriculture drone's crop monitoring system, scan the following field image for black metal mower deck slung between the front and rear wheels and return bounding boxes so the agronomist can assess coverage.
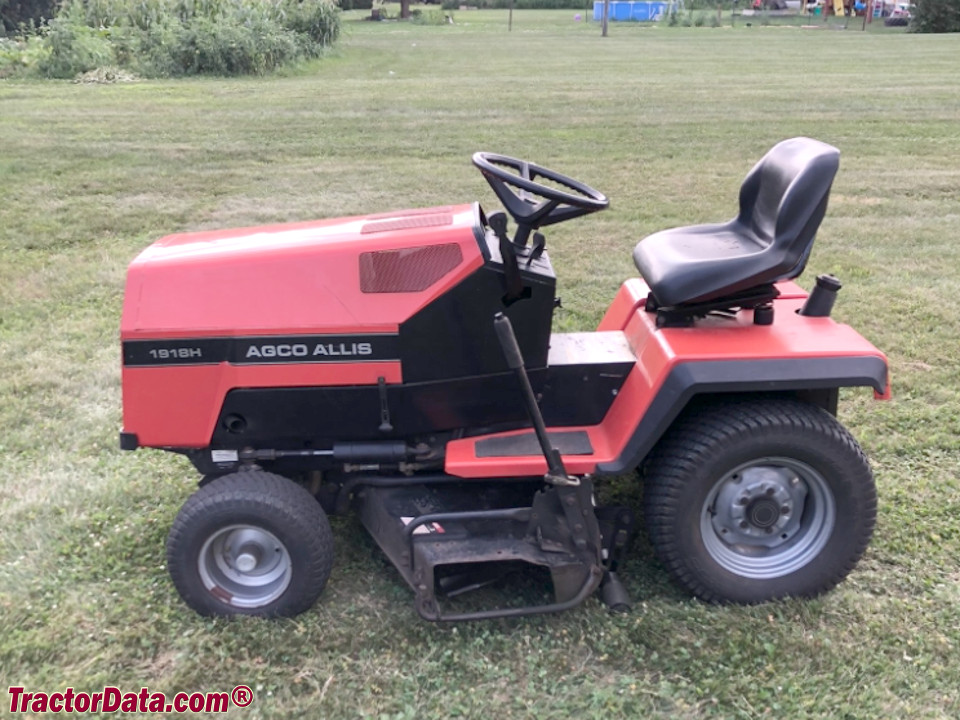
[356,477,620,620]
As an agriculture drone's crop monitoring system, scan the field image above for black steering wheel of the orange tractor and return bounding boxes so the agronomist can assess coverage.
[473,152,610,247]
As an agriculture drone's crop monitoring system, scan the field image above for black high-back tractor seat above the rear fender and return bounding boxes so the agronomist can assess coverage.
[633,137,840,307]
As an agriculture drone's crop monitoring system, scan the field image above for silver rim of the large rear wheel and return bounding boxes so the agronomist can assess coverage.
[700,457,837,580]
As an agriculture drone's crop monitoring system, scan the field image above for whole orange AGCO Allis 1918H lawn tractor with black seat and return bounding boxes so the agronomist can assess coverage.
[120,138,889,620]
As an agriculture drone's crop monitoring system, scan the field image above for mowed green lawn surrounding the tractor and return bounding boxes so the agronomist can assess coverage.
[0,11,960,719]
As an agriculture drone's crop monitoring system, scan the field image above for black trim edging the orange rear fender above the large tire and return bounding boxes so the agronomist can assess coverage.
[596,356,887,475]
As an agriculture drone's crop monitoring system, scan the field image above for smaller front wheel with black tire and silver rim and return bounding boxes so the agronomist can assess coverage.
[167,471,333,616]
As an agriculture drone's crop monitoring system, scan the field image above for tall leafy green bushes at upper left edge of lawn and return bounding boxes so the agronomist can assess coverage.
[0,0,340,78]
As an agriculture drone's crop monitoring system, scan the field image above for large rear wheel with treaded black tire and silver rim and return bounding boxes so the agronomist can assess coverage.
[645,399,877,603]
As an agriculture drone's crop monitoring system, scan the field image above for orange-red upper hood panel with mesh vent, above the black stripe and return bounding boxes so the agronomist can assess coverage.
[121,204,483,340]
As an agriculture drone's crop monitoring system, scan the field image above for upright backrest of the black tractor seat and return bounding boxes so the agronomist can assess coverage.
[738,137,840,280]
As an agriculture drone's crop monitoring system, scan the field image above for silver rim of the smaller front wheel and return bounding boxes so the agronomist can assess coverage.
[197,525,293,608]
